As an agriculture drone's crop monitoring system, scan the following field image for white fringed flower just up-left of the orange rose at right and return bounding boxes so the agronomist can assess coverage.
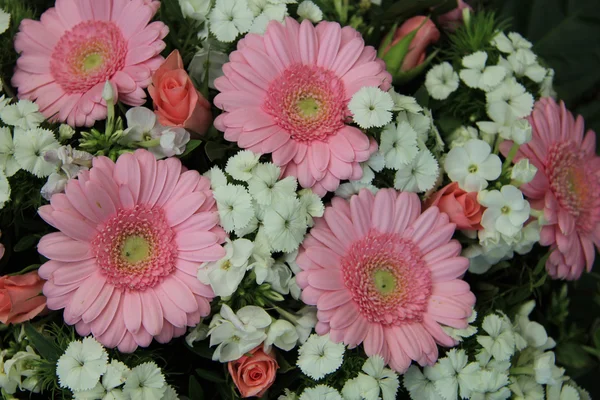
[394,149,440,193]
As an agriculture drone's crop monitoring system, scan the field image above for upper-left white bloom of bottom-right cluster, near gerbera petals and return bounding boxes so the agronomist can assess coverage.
[477,314,515,361]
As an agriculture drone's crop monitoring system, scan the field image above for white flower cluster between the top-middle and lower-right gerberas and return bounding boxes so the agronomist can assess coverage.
[336,88,443,199]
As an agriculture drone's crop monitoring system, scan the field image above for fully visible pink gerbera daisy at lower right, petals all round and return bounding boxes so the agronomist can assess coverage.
[296,189,475,372]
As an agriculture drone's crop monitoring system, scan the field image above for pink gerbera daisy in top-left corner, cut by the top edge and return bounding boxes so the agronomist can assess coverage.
[12,0,169,126]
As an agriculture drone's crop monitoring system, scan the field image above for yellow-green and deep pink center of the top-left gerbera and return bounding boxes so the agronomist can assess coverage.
[50,21,127,94]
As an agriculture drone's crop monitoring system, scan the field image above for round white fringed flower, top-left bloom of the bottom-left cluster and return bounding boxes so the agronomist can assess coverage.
[56,337,108,391]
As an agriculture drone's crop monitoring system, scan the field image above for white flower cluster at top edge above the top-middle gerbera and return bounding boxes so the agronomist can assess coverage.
[203,0,323,43]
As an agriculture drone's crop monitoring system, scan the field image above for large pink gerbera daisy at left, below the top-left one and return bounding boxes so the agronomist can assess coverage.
[38,150,225,352]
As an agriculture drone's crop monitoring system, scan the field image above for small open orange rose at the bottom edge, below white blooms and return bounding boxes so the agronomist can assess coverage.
[227,346,279,397]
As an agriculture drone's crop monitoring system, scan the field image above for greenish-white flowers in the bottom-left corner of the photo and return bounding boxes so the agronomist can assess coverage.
[0,346,41,395]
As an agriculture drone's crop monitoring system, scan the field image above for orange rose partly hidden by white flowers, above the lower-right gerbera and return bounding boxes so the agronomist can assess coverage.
[425,182,485,230]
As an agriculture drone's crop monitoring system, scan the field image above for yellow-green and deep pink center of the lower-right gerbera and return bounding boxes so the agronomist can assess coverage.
[341,231,432,326]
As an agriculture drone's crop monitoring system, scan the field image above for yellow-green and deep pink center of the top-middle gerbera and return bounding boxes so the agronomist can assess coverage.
[263,64,349,142]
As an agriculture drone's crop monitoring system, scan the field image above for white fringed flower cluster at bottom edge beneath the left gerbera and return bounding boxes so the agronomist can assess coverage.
[56,337,179,400]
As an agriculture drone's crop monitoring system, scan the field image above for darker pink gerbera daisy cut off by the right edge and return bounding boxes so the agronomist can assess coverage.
[502,98,600,280]
